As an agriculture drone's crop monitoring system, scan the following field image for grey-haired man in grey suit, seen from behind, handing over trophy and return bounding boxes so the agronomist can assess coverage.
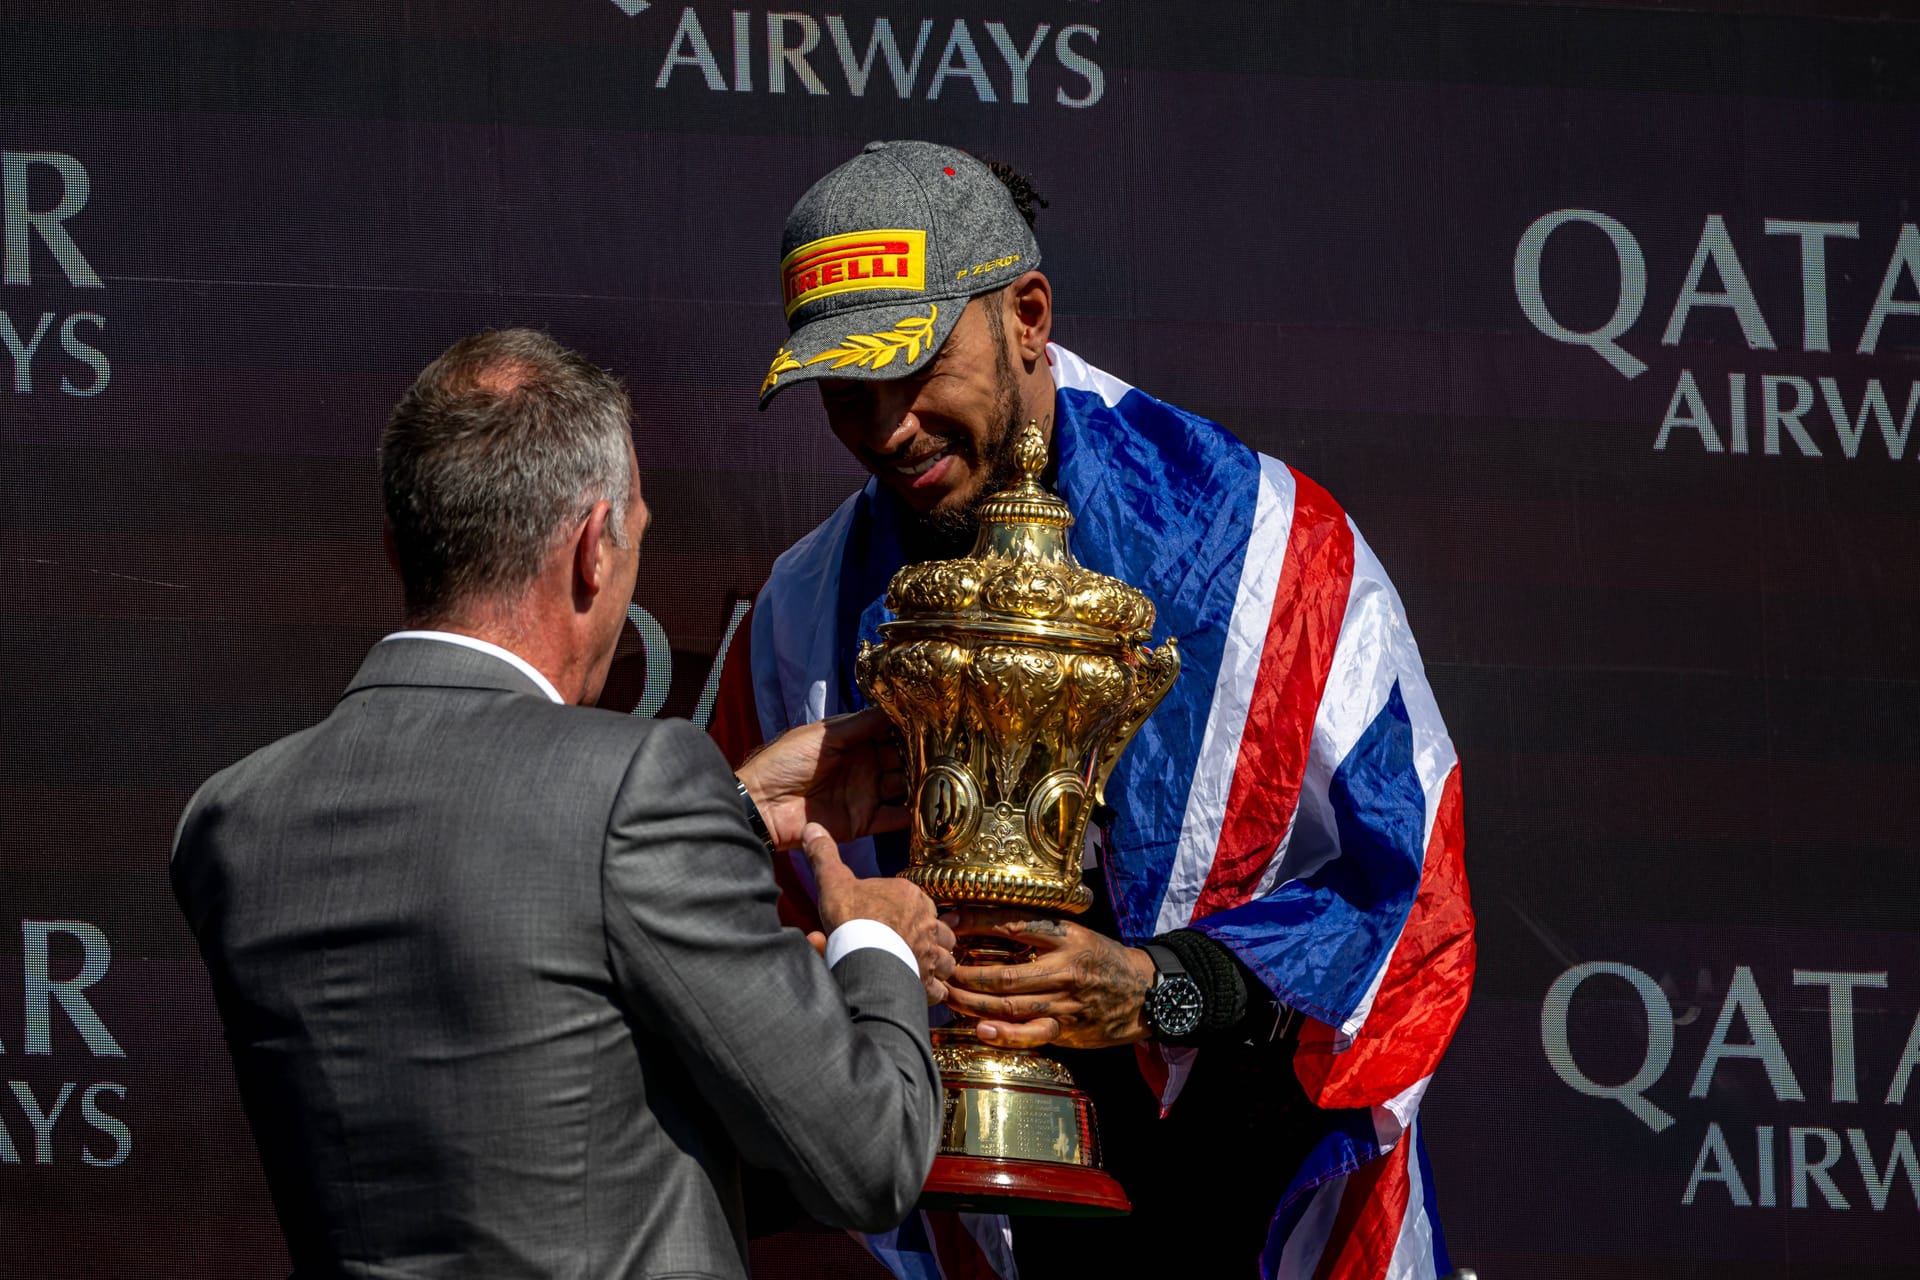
[173,330,952,1280]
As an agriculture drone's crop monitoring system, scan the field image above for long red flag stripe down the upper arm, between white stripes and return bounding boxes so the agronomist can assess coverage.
[1194,472,1354,919]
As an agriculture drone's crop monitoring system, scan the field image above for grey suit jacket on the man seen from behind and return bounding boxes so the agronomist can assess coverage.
[173,639,941,1280]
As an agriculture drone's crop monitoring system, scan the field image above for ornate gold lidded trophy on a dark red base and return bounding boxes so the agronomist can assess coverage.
[856,422,1181,1215]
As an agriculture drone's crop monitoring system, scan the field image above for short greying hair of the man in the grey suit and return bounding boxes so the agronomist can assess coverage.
[380,328,634,622]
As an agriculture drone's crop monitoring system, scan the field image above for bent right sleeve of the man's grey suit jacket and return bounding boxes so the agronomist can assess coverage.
[603,722,941,1230]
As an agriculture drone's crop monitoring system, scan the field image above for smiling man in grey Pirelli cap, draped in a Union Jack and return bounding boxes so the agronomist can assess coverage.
[714,142,1475,1280]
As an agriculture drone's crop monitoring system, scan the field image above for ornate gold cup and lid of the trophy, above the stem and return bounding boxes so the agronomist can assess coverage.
[856,422,1179,913]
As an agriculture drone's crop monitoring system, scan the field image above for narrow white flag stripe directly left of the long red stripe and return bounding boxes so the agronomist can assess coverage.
[1154,455,1294,933]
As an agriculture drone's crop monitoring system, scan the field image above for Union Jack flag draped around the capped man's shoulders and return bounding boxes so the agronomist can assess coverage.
[714,347,1475,1280]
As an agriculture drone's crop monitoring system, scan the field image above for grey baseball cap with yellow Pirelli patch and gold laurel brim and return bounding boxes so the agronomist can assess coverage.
[760,142,1041,409]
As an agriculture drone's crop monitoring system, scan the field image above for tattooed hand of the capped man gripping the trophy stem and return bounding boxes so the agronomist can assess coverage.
[945,908,1154,1050]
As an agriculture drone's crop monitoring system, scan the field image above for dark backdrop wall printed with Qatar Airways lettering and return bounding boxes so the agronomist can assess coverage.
[0,0,1920,1280]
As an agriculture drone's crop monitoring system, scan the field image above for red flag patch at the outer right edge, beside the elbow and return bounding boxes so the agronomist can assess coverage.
[1294,766,1475,1105]
